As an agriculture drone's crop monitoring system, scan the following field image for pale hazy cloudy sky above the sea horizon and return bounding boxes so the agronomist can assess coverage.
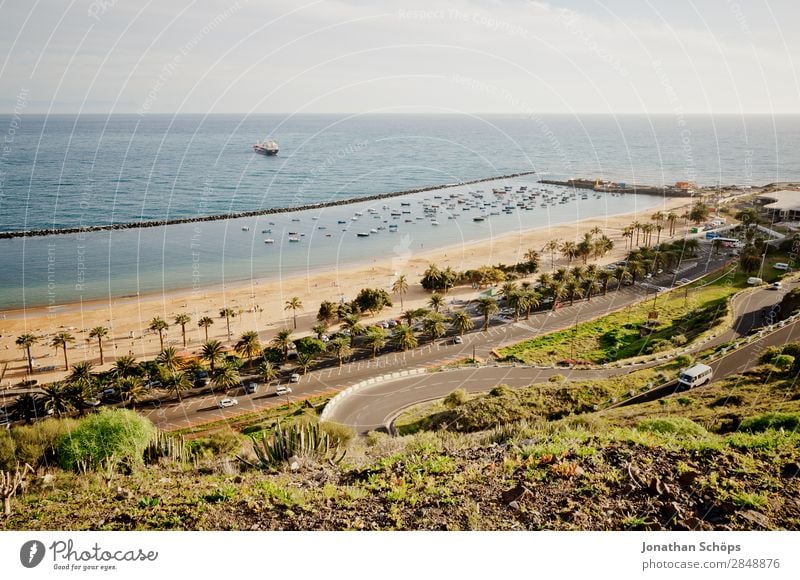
[0,0,800,115]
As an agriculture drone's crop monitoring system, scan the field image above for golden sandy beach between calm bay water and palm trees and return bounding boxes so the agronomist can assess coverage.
[0,198,689,387]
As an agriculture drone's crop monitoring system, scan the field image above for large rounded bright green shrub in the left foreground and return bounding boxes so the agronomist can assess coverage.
[58,409,156,471]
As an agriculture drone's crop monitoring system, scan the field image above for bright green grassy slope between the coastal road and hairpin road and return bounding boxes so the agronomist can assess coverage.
[497,271,764,364]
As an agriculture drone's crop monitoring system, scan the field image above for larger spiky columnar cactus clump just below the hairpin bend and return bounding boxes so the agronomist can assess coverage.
[242,423,346,469]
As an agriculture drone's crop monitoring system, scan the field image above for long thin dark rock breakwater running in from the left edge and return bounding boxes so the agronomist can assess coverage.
[0,171,536,239]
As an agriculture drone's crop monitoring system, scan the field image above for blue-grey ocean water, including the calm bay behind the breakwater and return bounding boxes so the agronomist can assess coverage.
[0,115,800,309]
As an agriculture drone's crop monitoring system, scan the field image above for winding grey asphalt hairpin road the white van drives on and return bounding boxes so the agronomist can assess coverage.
[330,272,800,433]
